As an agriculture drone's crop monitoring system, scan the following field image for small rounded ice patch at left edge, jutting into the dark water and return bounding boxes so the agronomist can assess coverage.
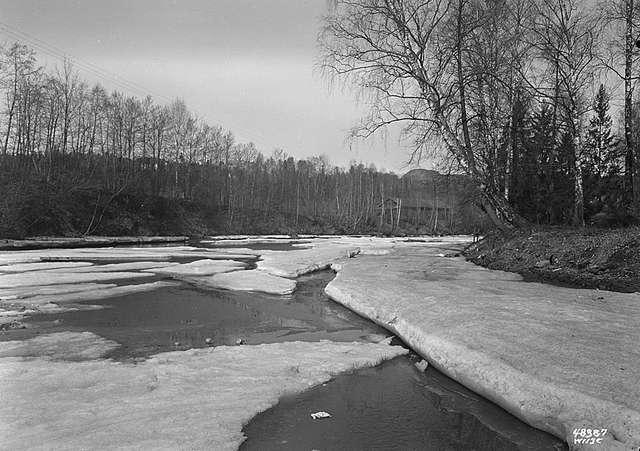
[0,332,119,360]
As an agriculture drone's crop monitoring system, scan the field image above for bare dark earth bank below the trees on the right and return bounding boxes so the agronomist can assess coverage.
[465,227,640,293]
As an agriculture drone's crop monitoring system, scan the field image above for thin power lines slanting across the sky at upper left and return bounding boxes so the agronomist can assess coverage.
[0,21,172,102]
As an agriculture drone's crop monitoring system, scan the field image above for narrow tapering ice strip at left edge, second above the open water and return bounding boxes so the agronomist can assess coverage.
[0,271,154,288]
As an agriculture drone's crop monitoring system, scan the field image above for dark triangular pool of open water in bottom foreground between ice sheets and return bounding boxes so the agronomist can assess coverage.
[240,357,567,451]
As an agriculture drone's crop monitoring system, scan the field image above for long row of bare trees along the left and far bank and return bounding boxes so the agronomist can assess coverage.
[0,43,482,237]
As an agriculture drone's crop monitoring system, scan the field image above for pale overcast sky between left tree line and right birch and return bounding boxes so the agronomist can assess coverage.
[0,0,424,172]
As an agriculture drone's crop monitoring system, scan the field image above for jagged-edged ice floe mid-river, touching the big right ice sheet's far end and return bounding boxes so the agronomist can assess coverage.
[258,245,360,278]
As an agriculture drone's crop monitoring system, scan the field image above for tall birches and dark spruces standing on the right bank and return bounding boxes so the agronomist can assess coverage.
[319,0,640,229]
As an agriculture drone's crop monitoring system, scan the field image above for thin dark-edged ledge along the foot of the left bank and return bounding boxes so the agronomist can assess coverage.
[0,236,189,251]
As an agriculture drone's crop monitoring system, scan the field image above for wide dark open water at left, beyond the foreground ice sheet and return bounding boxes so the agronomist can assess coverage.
[8,271,385,360]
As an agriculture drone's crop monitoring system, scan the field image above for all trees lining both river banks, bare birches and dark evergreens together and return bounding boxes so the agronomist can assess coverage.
[0,0,640,237]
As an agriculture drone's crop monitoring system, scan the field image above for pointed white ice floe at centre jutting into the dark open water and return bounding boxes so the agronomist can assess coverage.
[185,269,296,295]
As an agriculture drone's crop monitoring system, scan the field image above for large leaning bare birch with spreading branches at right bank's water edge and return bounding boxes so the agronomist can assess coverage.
[319,0,526,228]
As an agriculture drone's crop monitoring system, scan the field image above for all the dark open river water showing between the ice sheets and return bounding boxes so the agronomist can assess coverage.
[0,238,566,450]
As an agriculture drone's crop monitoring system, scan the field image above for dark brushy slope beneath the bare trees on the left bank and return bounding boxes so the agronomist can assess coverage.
[0,181,472,239]
